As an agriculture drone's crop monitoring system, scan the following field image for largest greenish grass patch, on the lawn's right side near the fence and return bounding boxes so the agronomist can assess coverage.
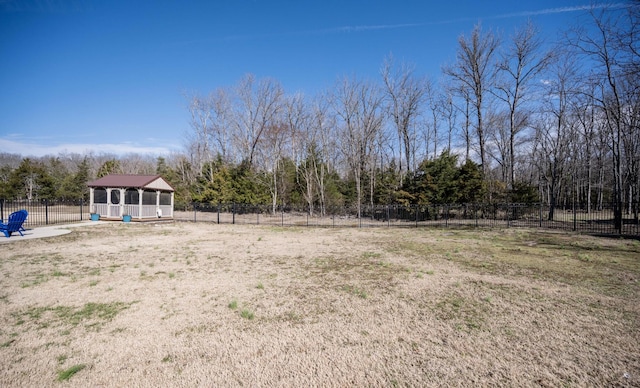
[393,228,640,296]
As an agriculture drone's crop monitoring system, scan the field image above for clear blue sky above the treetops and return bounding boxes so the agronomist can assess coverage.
[0,0,620,156]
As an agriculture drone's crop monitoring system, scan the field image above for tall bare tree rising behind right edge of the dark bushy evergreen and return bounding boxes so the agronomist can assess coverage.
[444,25,500,174]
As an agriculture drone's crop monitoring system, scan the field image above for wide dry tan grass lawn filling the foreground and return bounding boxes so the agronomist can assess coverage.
[0,223,640,387]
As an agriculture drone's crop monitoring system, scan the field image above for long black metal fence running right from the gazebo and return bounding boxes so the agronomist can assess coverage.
[174,203,640,236]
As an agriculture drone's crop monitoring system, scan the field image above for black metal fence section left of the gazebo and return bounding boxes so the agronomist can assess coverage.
[0,199,90,228]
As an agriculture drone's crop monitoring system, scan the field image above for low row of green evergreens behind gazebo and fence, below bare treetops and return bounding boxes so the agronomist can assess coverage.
[0,152,484,213]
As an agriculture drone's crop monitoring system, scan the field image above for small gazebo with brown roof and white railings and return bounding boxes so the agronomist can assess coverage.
[88,174,174,220]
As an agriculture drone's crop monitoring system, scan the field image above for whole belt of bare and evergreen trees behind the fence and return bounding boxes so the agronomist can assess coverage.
[0,3,640,226]
